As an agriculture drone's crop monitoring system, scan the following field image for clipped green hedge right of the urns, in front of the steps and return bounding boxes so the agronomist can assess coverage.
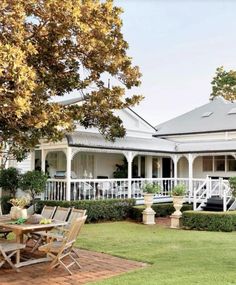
[183,211,236,232]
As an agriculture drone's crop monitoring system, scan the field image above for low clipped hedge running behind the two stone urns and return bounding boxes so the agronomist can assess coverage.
[130,203,193,222]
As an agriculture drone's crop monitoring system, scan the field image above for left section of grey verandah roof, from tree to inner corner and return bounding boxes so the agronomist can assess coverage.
[67,132,175,153]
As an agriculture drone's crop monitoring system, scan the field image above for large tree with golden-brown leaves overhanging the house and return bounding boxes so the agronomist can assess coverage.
[0,0,141,162]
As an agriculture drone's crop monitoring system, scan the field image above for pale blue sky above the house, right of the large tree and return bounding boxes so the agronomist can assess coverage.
[114,0,236,126]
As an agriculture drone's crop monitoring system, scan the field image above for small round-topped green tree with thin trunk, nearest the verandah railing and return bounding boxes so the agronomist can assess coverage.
[20,170,48,211]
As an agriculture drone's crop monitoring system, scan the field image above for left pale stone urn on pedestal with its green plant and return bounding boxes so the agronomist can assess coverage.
[142,183,161,225]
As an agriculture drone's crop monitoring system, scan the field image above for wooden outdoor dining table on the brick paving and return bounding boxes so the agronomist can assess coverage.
[0,218,67,267]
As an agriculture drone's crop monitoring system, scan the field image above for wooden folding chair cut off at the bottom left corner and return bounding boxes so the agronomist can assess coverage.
[0,241,25,272]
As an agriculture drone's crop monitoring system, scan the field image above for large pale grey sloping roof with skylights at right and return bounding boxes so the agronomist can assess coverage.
[155,97,236,137]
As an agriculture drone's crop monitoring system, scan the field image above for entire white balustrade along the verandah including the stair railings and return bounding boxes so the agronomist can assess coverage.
[43,177,232,210]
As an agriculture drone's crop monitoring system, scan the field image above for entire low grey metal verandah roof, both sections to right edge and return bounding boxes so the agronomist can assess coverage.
[67,132,236,154]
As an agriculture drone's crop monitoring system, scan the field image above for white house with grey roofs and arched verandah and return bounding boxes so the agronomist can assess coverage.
[12,97,236,210]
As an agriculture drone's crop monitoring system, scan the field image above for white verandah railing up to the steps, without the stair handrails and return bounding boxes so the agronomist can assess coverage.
[43,178,205,203]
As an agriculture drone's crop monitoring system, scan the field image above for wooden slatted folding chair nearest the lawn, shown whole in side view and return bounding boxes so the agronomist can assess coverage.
[39,216,87,275]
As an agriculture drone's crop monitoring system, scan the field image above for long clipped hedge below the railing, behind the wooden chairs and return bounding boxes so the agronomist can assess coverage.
[37,199,135,223]
